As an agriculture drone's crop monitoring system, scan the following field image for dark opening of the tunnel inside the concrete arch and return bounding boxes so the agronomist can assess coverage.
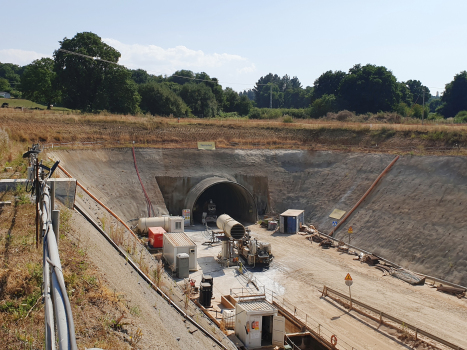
[192,182,256,226]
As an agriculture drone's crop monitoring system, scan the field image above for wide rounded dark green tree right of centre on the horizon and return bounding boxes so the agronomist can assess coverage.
[338,64,401,113]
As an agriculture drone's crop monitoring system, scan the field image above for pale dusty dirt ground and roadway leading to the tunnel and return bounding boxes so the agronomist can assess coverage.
[179,225,467,350]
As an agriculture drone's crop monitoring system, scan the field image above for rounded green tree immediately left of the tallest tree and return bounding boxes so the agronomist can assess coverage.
[21,57,60,109]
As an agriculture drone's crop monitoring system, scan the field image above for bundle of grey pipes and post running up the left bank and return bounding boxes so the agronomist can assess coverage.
[23,145,78,350]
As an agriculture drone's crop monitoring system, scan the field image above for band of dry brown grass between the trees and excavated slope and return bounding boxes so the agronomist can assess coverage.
[0,110,467,154]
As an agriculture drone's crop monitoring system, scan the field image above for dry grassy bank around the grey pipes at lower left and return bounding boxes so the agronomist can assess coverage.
[0,188,142,350]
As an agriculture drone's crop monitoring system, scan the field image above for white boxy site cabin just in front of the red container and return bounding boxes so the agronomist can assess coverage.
[162,232,197,271]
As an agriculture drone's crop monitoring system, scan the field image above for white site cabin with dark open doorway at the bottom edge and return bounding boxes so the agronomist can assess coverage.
[235,300,285,349]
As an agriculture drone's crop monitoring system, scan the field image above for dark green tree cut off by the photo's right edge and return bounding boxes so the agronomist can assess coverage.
[438,71,467,118]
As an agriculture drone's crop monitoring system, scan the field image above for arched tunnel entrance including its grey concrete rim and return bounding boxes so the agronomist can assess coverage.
[185,177,257,224]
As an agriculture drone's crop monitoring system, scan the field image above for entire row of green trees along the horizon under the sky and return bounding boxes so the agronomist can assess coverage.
[0,32,467,121]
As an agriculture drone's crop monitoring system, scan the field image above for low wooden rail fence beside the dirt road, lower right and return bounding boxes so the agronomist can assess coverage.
[323,286,462,350]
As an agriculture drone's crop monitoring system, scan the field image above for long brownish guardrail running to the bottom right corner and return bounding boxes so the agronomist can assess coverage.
[323,286,463,350]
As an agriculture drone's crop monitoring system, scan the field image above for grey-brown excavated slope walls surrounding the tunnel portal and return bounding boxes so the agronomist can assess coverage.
[51,149,467,285]
